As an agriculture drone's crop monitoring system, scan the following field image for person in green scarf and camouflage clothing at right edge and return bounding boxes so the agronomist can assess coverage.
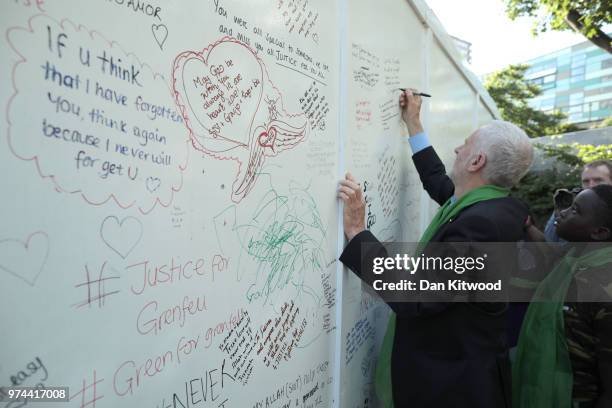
[513,184,612,408]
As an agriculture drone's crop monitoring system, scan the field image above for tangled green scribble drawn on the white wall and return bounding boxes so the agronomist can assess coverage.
[213,173,328,349]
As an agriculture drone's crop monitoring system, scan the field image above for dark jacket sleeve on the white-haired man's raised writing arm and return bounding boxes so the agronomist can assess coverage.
[412,146,455,205]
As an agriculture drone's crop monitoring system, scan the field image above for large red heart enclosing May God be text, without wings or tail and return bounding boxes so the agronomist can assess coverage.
[174,38,264,159]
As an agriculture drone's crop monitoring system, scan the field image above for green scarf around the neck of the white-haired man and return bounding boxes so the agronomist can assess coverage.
[374,185,510,408]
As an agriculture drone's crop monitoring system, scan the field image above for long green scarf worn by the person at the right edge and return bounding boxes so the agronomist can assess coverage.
[512,248,612,408]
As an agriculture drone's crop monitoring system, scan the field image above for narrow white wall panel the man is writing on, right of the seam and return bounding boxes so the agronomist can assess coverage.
[341,0,424,407]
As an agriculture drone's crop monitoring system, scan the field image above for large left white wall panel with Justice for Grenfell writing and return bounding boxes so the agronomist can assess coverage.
[0,0,338,407]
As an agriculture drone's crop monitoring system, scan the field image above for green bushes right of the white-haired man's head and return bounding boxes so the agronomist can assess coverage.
[513,143,612,229]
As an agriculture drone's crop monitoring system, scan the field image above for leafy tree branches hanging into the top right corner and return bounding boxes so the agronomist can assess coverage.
[505,0,612,39]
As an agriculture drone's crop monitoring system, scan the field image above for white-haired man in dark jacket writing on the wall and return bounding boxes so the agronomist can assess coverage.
[338,90,533,408]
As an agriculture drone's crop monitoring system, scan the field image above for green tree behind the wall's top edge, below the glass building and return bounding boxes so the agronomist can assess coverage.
[484,64,578,137]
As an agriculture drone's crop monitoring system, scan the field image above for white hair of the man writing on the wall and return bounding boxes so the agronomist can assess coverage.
[476,120,533,188]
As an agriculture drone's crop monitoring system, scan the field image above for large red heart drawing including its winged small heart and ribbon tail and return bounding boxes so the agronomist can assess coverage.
[173,37,309,202]
